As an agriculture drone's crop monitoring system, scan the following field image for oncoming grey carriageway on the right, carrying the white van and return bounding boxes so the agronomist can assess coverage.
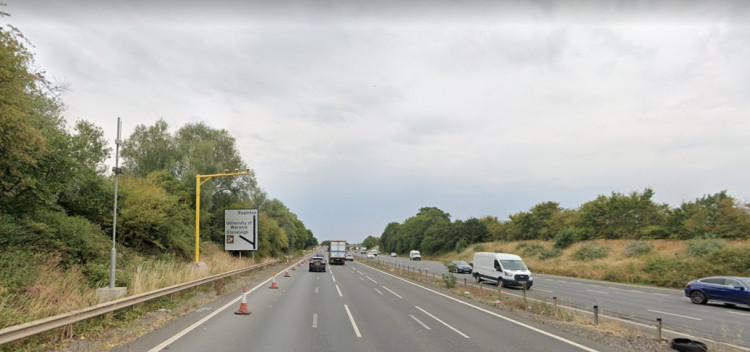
[368,255,750,351]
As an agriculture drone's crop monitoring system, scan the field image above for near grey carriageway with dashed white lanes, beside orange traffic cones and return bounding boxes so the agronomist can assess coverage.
[115,261,636,352]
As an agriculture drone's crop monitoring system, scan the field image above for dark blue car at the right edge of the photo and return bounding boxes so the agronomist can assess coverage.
[685,276,750,306]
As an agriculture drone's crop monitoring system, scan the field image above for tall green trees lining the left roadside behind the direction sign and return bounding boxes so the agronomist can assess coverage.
[0,21,317,294]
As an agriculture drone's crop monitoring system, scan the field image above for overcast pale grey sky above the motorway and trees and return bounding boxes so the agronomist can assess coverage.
[5,0,750,242]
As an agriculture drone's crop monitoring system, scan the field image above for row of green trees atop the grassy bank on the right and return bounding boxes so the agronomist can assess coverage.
[379,188,750,254]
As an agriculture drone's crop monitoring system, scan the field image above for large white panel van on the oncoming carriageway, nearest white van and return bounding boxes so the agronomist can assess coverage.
[471,252,534,290]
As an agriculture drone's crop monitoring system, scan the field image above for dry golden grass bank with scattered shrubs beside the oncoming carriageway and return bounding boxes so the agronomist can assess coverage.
[429,240,750,288]
